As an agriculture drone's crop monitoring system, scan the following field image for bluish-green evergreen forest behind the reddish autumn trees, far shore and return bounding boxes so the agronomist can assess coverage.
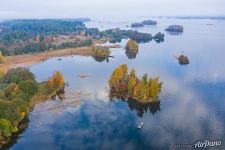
[0,19,85,45]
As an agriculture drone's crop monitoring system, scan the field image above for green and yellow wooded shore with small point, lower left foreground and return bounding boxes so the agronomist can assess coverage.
[0,68,65,148]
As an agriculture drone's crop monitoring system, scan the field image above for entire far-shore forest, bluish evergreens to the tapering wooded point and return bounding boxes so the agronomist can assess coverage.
[0,19,164,56]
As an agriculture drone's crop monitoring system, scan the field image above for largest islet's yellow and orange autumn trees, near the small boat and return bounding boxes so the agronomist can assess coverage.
[109,64,162,103]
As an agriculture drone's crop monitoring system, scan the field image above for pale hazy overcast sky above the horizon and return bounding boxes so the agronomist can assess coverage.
[0,0,225,19]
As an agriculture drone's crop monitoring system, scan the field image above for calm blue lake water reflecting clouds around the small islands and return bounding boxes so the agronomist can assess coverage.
[11,17,225,150]
